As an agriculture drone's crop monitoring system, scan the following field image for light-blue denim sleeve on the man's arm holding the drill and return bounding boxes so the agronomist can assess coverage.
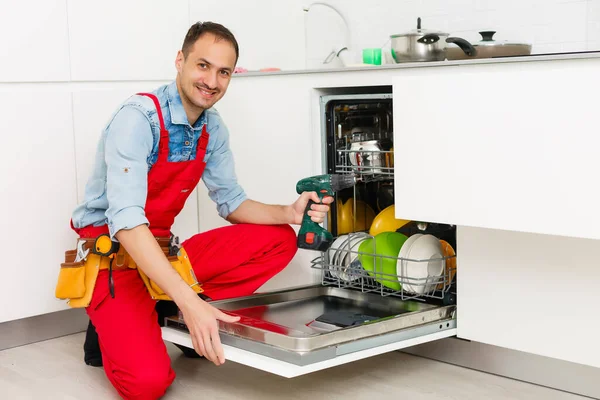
[202,121,247,219]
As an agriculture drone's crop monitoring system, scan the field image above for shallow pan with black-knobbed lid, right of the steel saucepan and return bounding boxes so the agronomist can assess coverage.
[446,31,531,60]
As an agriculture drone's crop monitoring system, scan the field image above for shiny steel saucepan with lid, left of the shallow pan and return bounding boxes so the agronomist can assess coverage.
[390,18,476,63]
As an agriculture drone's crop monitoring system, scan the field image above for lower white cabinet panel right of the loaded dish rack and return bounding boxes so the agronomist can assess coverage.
[458,227,600,368]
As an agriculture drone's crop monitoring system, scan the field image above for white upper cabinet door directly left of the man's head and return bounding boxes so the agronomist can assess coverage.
[69,0,189,81]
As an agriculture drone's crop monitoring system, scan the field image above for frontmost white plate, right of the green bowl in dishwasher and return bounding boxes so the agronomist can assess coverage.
[403,235,444,294]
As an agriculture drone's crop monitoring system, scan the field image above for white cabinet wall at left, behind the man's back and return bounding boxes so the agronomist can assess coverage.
[0,0,198,323]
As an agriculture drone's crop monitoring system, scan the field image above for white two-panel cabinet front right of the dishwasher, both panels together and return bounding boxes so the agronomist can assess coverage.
[393,59,600,367]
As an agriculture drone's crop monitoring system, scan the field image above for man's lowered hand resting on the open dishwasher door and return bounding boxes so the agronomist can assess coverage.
[180,297,240,365]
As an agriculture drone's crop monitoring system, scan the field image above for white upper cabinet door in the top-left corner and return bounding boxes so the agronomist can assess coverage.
[0,0,69,82]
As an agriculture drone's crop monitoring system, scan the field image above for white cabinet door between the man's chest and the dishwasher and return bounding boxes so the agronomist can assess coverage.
[198,76,321,292]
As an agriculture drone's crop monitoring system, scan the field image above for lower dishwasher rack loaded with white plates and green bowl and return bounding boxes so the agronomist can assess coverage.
[311,232,456,305]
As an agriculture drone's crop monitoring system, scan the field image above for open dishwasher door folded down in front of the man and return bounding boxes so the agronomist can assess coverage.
[162,285,456,378]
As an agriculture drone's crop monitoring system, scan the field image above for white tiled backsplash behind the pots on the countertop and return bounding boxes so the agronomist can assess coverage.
[305,0,600,67]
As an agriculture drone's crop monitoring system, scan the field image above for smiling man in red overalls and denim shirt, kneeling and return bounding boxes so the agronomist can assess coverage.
[65,22,333,399]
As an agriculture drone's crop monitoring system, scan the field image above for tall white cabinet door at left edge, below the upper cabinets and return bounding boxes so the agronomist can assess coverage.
[0,88,77,323]
